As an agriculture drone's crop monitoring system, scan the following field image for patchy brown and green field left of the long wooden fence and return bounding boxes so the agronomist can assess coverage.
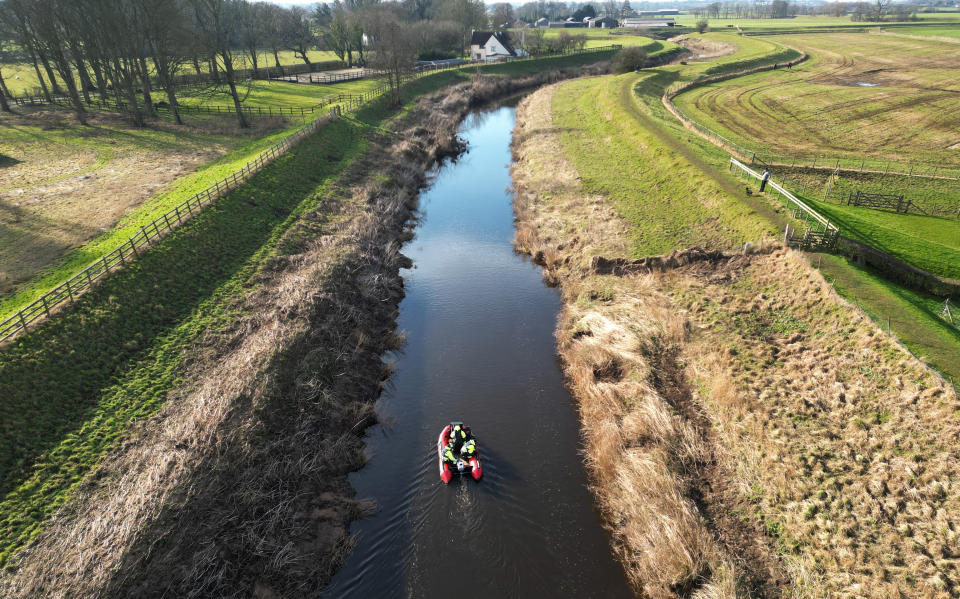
[0,80,378,318]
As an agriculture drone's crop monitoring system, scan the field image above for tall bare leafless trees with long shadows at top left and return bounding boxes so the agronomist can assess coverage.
[0,0,332,127]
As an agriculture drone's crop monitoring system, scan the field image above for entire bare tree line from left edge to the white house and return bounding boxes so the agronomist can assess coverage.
[0,0,488,127]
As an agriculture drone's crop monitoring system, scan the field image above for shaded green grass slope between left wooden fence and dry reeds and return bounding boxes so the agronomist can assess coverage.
[0,47,610,563]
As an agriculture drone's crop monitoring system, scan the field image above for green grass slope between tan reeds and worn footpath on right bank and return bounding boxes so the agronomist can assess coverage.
[553,74,772,258]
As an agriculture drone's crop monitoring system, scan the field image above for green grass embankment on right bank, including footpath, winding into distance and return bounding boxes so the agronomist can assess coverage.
[553,33,800,257]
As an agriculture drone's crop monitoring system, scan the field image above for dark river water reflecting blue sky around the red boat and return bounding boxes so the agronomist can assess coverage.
[327,108,631,599]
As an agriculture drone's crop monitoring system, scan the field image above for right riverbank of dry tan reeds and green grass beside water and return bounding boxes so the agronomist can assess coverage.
[515,36,960,597]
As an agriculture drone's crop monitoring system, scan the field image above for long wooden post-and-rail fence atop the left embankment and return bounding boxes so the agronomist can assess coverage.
[0,45,622,343]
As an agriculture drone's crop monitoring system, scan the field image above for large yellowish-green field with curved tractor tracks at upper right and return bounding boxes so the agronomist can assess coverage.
[674,34,960,170]
